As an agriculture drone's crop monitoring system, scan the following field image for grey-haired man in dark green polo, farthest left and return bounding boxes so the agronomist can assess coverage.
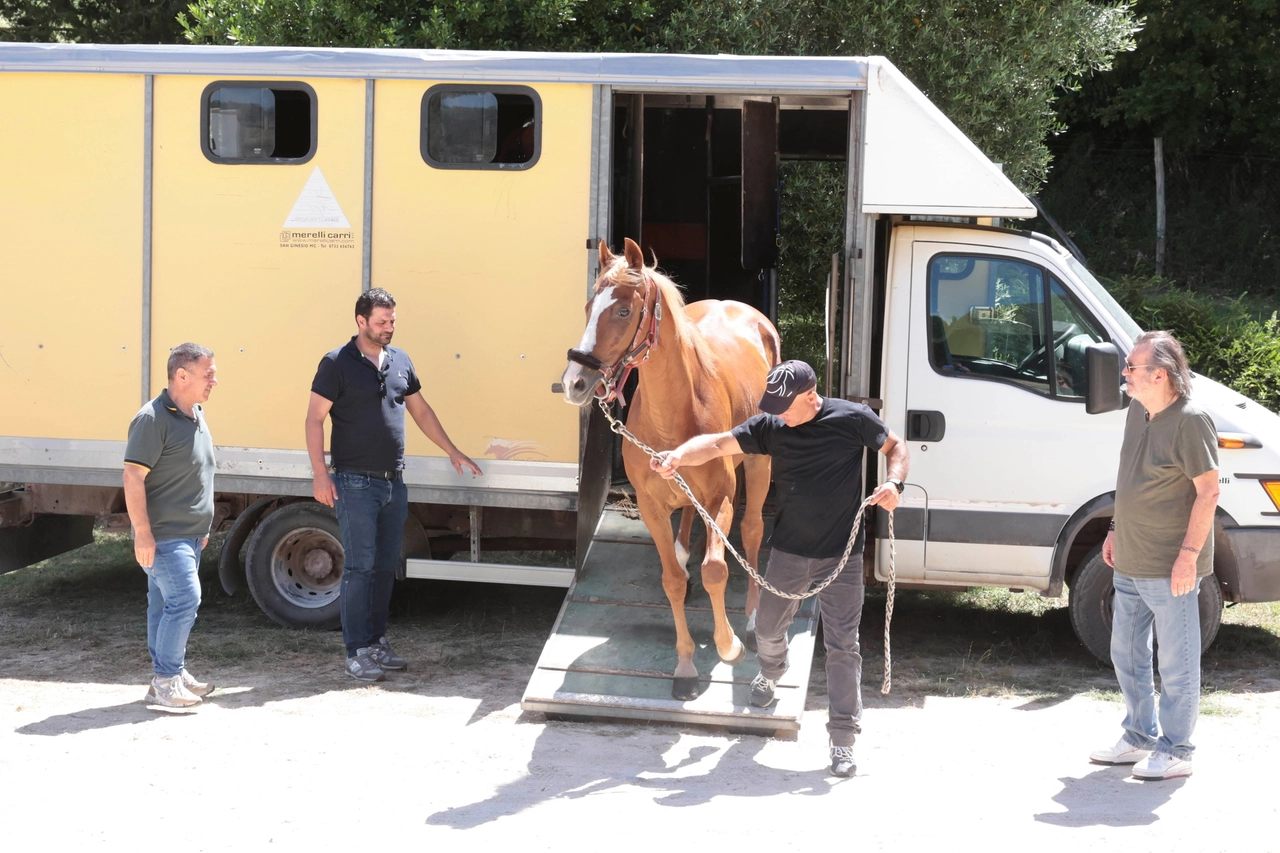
[124,343,218,708]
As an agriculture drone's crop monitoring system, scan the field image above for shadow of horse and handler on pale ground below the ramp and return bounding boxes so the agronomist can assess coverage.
[425,715,842,829]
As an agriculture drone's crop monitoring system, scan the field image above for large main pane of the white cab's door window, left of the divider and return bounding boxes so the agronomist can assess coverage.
[928,255,1052,396]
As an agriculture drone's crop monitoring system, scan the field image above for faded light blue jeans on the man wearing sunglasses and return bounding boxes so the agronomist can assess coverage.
[1111,573,1201,758]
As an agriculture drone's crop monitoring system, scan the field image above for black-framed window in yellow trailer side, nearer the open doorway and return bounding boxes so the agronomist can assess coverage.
[420,86,541,169]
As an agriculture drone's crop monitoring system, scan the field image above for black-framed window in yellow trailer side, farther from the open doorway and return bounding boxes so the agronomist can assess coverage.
[201,81,316,164]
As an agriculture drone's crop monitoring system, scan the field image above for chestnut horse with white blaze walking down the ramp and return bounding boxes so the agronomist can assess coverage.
[563,238,780,699]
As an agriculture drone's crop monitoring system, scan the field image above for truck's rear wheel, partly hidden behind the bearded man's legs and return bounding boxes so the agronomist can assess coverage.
[244,501,343,629]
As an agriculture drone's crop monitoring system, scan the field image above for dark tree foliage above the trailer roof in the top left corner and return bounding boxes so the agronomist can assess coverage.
[0,0,188,45]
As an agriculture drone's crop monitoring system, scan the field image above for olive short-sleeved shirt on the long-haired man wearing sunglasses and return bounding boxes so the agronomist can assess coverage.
[1115,397,1217,578]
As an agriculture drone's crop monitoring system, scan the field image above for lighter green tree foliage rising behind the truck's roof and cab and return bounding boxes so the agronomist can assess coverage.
[184,0,1137,190]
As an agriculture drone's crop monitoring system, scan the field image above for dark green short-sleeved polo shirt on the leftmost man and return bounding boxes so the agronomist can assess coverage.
[124,391,216,542]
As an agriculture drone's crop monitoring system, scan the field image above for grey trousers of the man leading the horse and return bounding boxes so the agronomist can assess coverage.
[755,549,864,747]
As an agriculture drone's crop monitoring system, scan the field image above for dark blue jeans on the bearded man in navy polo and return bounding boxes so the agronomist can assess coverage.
[333,471,408,657]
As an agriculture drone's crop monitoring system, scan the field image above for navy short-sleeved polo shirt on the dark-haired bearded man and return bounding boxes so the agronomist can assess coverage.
[311,337,422,471]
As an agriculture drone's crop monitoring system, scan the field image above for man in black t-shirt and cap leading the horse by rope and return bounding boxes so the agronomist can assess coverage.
[650,361,908,776]
